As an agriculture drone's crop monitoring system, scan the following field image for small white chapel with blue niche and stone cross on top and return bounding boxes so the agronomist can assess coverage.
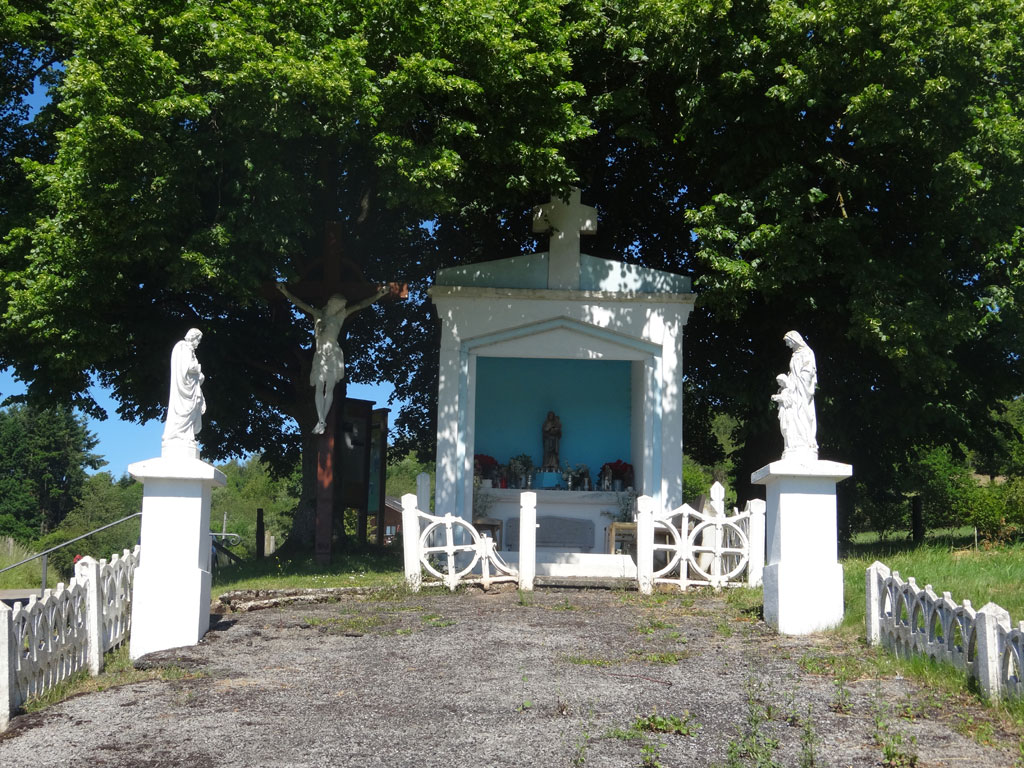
[429,189,694,575]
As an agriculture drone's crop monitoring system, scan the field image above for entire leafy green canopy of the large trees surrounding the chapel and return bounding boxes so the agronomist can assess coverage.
[0,0,1024,548]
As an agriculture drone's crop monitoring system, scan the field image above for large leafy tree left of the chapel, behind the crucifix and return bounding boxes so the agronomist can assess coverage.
[0,0,588,548]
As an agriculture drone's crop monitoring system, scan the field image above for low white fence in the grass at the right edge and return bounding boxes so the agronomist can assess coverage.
[865,561,1024,698]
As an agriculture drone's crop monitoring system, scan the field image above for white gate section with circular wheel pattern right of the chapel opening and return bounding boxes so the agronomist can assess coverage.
[637,482,765,595]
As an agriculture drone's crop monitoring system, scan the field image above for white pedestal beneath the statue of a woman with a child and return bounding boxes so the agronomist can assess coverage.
[751,459,853,635]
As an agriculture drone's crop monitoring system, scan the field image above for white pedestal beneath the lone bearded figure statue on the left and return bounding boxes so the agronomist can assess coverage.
[128,452,225,659]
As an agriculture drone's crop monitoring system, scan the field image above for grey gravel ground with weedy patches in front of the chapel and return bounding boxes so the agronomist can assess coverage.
[0,589,1020,768]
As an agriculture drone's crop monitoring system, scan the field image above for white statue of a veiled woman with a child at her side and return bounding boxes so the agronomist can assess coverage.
[771,331,818,459]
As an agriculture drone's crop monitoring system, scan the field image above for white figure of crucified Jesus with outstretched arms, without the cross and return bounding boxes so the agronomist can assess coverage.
[278,283,388,434]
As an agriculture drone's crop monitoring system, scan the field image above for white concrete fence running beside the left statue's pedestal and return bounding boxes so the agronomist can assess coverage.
[0,546,140,731]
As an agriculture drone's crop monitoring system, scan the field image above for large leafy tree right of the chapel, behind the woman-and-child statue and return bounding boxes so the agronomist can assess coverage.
[572,0,1024,512]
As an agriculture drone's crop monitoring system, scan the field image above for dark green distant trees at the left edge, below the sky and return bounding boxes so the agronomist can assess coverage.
[0,406,105,543]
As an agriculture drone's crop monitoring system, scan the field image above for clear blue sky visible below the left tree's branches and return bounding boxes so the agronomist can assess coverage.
[0,371,399,477]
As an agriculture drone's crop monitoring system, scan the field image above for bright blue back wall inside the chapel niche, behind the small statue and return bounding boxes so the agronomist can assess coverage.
[473,357,631,478]
